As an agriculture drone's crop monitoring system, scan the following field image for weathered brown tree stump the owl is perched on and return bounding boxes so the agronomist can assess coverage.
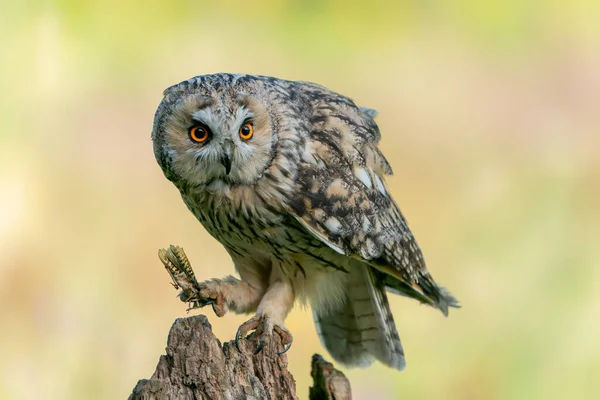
[129,315,352,400]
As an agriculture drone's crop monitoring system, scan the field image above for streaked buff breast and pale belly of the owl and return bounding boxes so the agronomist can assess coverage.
[183,186,349,310]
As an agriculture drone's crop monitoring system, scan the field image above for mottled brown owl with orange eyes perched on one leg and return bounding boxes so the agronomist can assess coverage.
[152,74,458,370]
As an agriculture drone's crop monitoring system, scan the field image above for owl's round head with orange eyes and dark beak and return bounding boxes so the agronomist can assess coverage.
[152,74,277,190]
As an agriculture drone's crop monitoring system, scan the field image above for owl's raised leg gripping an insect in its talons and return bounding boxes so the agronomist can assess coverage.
[198,276,264,317]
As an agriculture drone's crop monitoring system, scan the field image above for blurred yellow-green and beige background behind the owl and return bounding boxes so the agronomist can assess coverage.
[0,0,600,400]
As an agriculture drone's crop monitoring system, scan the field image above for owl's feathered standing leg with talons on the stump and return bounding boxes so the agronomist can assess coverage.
[235,280,294,354]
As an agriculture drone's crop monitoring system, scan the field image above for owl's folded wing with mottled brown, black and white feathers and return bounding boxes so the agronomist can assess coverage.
[290,88,458,314]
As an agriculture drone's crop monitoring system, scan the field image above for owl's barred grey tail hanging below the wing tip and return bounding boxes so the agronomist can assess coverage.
[313,266,406,370]
